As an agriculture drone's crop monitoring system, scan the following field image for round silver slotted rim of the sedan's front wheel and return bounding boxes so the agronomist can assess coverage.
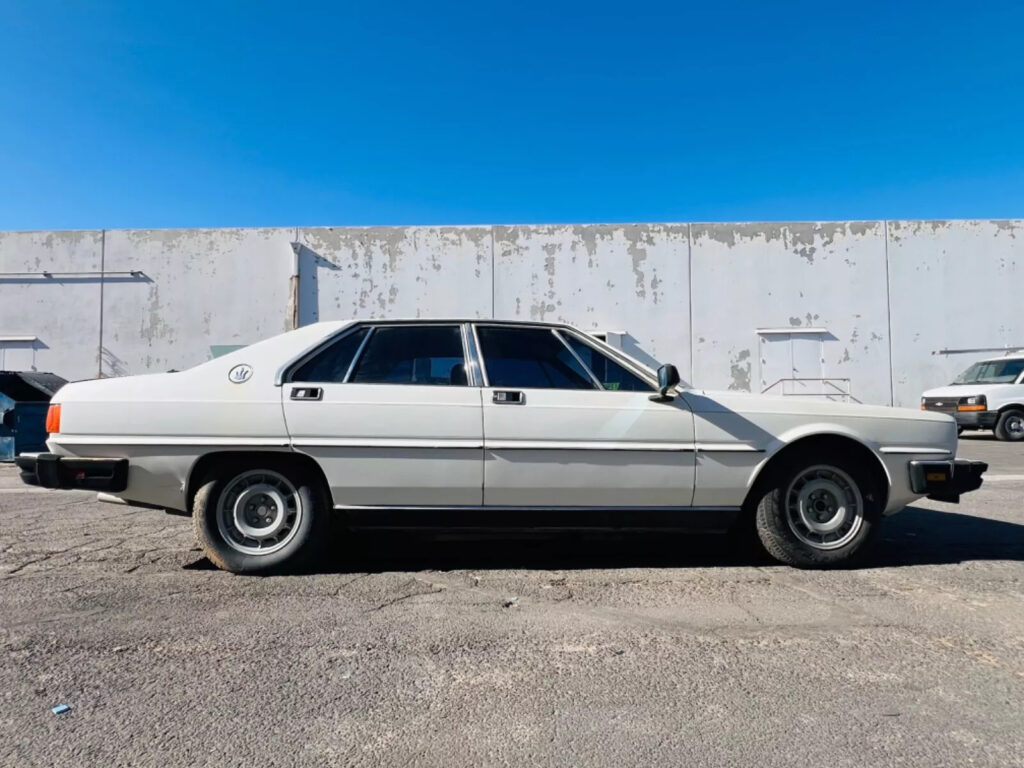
[784,464,864,550]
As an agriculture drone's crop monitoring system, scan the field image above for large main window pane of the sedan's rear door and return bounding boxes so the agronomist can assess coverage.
[349,326,468,386]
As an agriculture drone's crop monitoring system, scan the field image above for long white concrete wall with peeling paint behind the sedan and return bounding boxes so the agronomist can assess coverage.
[0,221,1024,406]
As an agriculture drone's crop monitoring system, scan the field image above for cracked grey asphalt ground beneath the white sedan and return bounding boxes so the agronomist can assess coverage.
[0,434,1024,768]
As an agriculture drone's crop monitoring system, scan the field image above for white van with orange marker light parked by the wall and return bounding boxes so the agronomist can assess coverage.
[921,352,1024,440]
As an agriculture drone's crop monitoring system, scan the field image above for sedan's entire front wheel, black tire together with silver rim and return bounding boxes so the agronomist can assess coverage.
[755,453,883,568]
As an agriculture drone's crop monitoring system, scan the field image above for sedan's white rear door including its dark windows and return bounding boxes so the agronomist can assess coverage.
[282,323,483,507]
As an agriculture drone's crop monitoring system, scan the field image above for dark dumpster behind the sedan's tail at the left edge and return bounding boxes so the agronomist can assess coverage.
[0,371,68,462]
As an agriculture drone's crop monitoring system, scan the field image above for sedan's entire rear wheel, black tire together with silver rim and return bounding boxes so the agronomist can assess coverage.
[193,463,331,573]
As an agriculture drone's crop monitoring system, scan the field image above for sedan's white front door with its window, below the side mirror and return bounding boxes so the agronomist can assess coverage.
[474,324,694,507]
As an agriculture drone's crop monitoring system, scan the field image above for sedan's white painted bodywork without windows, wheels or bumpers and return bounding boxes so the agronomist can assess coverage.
[48,321,956,520]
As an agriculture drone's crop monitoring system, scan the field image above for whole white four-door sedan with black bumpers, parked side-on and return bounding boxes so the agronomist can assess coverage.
[17,319,987,572]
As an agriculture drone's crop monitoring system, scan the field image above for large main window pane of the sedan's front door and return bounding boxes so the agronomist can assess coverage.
[476,326,597,389]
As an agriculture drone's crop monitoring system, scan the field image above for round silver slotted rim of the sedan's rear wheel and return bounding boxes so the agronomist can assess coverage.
[217,469,303,555]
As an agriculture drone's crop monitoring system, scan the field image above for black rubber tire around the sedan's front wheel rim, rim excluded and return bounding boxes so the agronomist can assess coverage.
[756,455,882,568]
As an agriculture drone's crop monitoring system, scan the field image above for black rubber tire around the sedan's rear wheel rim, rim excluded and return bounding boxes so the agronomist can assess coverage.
[193,466,328,573]
